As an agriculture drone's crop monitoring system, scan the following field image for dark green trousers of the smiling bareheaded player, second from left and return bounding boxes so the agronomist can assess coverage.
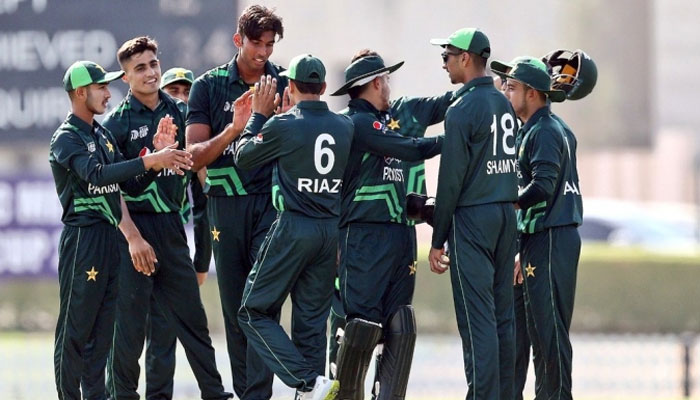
[107,213,231,400]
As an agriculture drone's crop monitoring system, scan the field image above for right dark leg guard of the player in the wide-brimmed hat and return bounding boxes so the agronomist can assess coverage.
[372,305,416,400]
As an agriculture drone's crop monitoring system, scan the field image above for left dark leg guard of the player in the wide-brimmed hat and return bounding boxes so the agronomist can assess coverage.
[337,319,382,400]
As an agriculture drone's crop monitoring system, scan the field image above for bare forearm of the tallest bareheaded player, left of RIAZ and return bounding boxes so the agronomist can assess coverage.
[186,124,241,171]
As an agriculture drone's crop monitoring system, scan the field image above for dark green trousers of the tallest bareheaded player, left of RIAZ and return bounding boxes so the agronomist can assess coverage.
[207,194,279,400]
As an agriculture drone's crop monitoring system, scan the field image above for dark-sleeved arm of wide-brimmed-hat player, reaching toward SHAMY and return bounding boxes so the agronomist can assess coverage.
[352,114,444,161]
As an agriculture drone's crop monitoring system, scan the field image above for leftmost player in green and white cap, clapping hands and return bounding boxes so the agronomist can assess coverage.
[49,61,192,400]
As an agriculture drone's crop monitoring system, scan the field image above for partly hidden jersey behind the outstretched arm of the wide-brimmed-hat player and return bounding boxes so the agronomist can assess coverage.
[385,92,453,226]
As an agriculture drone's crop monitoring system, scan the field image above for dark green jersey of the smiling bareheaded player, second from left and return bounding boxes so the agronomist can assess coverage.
[102,90,187,213]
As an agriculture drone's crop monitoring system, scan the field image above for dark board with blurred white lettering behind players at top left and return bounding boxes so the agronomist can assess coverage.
[0,0,237,144]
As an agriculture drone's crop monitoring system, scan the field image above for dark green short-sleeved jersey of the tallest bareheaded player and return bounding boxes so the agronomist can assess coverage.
[187,55,287,196]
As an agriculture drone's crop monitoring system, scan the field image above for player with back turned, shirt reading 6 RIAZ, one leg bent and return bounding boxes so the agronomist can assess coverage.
[236,54,353,399]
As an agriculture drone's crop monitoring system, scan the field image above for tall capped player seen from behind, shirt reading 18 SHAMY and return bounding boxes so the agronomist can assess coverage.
[429,28,518,399]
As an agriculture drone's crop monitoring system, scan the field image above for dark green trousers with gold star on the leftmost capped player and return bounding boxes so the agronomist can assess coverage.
[54,222,120,400]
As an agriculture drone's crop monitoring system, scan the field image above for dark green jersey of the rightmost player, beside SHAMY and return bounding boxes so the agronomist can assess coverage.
[517,106,583,233]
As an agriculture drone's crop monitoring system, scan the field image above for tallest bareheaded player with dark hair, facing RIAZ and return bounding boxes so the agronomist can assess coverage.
[187,5,287,400]
